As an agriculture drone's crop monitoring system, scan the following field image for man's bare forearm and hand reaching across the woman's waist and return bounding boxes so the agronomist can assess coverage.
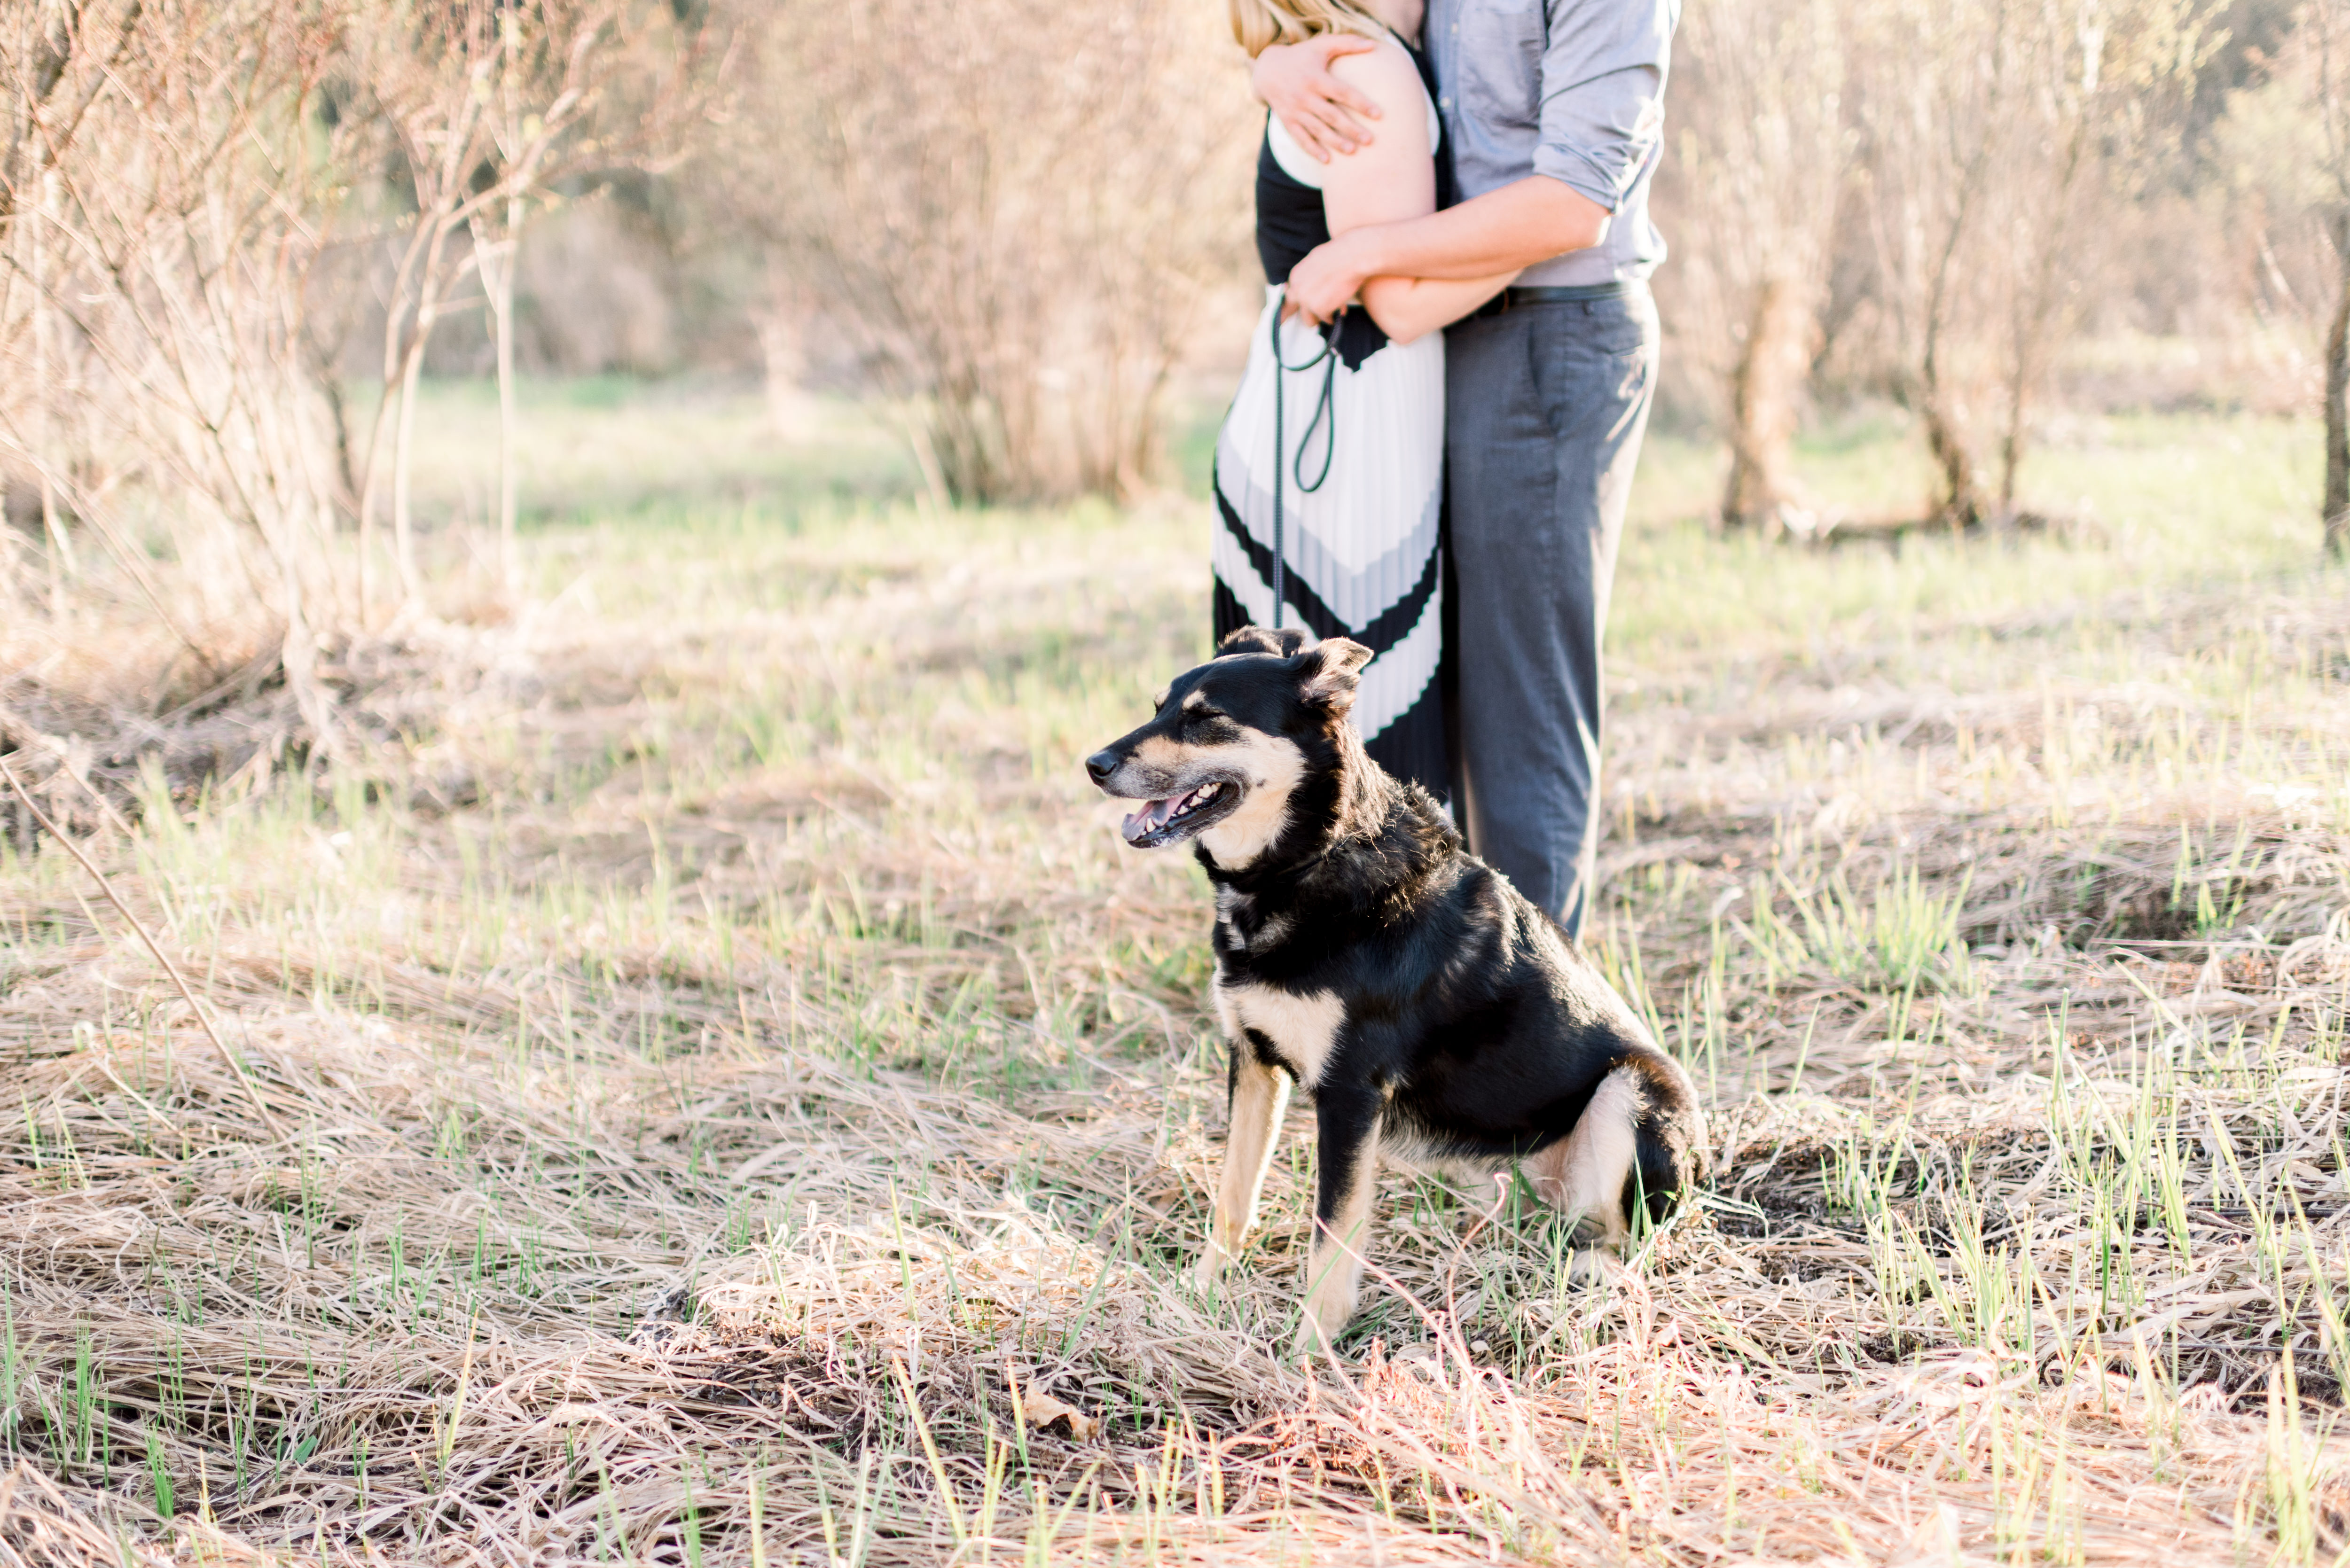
[1288,174,1610,322]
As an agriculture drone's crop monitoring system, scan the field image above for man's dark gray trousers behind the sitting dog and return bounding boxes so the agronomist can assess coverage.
[1445,284,1659,936]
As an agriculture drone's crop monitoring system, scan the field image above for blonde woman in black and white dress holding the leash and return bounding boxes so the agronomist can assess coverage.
[1213,0,1516,797]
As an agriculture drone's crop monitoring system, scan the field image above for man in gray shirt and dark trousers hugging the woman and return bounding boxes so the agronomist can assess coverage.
[1253,0,1680,936]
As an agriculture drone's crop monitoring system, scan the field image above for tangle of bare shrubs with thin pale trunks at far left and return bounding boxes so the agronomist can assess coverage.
[0,0,698,804]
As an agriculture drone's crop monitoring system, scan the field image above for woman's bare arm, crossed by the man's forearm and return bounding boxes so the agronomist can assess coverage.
[1323,47,1518,343]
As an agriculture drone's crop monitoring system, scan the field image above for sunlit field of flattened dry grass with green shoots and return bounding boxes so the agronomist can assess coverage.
[0,383,2350,1568]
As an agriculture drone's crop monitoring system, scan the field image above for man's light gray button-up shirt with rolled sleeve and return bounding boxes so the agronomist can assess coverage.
[1424,0,1683,284]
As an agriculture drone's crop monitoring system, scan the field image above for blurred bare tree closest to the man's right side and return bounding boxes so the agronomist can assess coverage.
[1668,0,1852,527]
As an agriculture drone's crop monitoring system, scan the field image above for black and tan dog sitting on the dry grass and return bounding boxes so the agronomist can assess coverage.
[1086,625,1706,1350]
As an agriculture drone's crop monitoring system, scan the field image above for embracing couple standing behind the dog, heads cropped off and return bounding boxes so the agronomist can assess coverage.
[1213,0,1680,936]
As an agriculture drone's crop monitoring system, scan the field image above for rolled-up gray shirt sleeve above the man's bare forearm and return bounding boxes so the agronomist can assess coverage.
[1535,0,1683,211]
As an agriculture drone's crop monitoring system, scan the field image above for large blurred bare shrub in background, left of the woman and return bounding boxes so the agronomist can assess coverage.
[728,0,1253,501]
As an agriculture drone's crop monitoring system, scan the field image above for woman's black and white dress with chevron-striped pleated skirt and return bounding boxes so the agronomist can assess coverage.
[1210,40,1450,799]
